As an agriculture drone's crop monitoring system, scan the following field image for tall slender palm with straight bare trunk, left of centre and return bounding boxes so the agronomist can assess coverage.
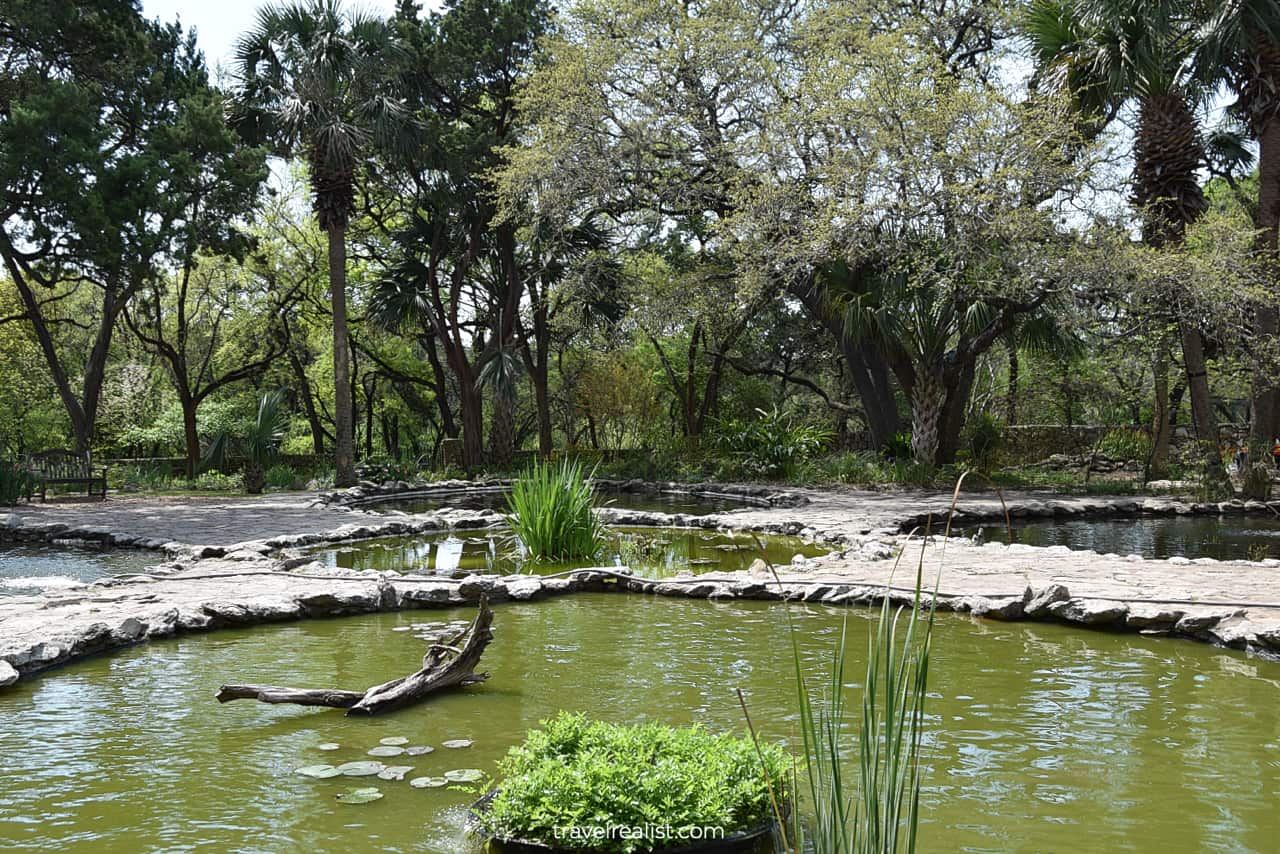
[230,0,404,485]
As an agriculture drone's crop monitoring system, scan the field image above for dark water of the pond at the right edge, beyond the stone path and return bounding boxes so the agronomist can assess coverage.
[988,516,1280,561]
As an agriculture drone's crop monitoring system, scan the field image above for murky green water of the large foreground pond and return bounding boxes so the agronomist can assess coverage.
[0,594,1280,854]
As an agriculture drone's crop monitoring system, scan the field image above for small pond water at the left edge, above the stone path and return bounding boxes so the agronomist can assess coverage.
[0,543,164,595]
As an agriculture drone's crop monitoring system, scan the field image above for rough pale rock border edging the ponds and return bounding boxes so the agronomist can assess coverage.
[0,481,1280,686]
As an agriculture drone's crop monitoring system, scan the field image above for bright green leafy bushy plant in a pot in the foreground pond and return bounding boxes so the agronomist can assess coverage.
[472,712,791,854]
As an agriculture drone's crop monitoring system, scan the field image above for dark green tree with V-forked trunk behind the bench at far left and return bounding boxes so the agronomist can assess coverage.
[0,0,264,449]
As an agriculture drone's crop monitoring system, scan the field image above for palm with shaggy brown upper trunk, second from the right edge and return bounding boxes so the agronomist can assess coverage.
[1024,0,1230,489]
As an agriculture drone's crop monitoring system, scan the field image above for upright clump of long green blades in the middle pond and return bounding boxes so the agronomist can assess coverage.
[507,460,605,561]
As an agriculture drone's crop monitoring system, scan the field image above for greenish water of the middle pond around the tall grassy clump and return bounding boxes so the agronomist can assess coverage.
[310,528,832,577]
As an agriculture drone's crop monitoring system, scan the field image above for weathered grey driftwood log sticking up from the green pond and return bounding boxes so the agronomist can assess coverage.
[218,598,493,714]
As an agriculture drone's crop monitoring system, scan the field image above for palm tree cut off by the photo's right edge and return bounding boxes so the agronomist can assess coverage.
[1196,0,1280,448]
